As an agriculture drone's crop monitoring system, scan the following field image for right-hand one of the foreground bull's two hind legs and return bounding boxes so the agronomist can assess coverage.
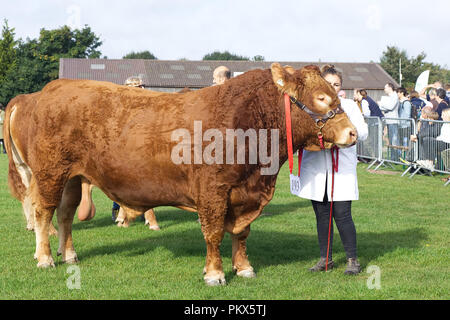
[57,177,81,263]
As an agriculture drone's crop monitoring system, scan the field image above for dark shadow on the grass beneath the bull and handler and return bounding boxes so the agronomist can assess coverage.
[75,221,428,270]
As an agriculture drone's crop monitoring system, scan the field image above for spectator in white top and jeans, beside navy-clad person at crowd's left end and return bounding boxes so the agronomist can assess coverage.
[378,83,400,161]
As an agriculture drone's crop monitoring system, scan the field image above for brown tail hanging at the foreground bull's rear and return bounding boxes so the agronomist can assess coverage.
[3,99,27,202]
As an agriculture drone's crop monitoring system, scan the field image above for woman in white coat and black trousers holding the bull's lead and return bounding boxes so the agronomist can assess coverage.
[299,65,368,274]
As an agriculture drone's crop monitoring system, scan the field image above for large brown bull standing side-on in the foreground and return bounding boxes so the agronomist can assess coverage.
[4,64,356,285]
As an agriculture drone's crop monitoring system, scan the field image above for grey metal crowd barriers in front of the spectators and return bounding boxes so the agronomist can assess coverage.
[357,116,450,185]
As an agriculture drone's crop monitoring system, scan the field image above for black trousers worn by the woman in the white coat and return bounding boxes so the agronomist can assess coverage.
[311,192,357,261]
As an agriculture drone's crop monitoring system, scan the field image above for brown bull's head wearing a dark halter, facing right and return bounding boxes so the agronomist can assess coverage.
[271,63,357,150]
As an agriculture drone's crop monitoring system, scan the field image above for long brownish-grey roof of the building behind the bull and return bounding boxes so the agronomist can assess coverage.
[59,58,398,89]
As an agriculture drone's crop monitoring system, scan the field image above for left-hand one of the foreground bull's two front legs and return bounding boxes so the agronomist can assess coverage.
[198,194,227,286]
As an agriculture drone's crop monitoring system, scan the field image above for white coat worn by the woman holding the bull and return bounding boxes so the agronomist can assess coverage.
[299,99,368,201]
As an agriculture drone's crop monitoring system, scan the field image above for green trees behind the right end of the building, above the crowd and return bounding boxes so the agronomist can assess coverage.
[380,46,450,89]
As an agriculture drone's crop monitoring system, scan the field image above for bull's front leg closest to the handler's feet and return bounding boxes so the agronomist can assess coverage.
[231,226,256,278]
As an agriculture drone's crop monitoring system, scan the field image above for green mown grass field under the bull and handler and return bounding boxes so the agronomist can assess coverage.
[0,154,450,300]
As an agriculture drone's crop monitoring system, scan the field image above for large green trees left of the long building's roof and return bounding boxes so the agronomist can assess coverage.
[0,22,102,105]
